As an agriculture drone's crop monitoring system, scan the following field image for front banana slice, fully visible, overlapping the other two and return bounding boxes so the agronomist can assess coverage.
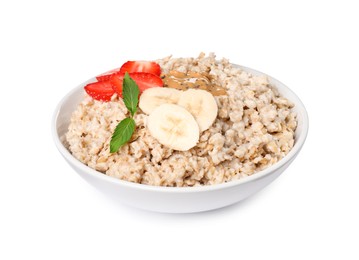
[146,103,199,151]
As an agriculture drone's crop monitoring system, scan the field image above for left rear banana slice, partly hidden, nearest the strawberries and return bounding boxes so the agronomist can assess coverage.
[139,87,181,114]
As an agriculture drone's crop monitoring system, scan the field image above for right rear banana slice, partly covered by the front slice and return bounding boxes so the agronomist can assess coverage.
[177,89,218,132]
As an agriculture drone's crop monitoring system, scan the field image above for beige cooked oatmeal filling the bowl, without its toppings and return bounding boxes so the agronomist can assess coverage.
[66,54,297,187]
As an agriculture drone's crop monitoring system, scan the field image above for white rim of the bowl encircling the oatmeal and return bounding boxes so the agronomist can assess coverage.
[51,64,309,193]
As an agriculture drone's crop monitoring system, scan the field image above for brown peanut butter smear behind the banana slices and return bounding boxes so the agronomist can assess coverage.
[161,70,227,96]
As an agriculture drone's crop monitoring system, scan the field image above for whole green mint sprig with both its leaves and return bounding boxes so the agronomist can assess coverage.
[110,72,140,153]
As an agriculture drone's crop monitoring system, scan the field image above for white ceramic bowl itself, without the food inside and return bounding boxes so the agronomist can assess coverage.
[52,66,308,213]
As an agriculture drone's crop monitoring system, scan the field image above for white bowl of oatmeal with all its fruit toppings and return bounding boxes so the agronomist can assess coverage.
[52,53,308,213]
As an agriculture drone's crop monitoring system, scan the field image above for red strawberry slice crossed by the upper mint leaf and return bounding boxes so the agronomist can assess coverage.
[109,72,163,97]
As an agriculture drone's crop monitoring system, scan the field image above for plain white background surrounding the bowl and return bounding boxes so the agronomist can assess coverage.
[0,0,359,259]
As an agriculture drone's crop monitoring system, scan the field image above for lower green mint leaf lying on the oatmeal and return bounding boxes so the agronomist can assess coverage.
[110,117,136,153]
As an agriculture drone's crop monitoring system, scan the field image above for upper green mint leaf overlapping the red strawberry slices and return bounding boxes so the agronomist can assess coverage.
[122,72,140,116]
